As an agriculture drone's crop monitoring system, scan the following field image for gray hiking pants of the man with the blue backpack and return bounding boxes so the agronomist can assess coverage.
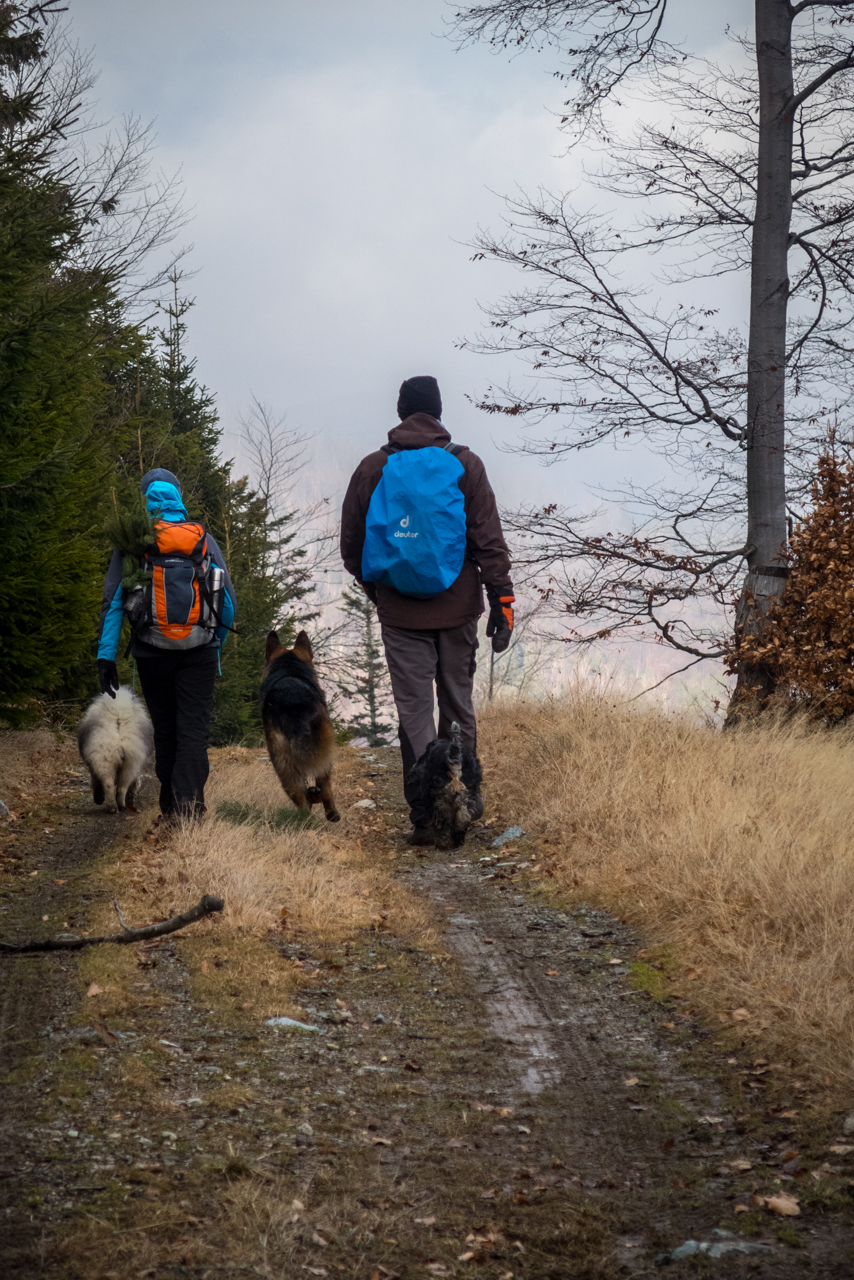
[382,618,478,823]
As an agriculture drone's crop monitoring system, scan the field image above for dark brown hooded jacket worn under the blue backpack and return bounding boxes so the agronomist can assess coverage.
[341,413,513,631]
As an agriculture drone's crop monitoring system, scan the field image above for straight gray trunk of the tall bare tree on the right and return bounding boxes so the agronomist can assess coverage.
[727,0,794,718]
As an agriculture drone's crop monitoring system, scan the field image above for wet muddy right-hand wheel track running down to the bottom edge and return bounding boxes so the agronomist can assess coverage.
[402,854,853,1277]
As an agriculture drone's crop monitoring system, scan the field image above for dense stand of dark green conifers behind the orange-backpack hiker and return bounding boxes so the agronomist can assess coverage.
[0,10,318,741]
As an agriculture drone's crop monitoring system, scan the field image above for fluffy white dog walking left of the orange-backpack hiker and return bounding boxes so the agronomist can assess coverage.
[77,689,154,813]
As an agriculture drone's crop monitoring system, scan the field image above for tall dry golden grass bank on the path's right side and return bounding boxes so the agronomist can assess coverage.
[480,691,854,1094]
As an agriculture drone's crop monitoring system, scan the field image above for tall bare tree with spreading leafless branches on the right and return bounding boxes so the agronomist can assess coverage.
[456,0,854,711]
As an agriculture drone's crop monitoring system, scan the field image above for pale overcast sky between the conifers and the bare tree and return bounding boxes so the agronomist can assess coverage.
[68,0,750,524]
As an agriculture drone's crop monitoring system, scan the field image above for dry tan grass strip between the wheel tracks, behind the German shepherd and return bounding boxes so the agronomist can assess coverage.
[78,748,435,1018]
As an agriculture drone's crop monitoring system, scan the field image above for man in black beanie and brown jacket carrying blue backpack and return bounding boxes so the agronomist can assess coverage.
[341,376,513,845]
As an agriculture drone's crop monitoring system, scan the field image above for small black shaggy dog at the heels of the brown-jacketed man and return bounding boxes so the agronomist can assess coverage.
[408,721,483,849]
